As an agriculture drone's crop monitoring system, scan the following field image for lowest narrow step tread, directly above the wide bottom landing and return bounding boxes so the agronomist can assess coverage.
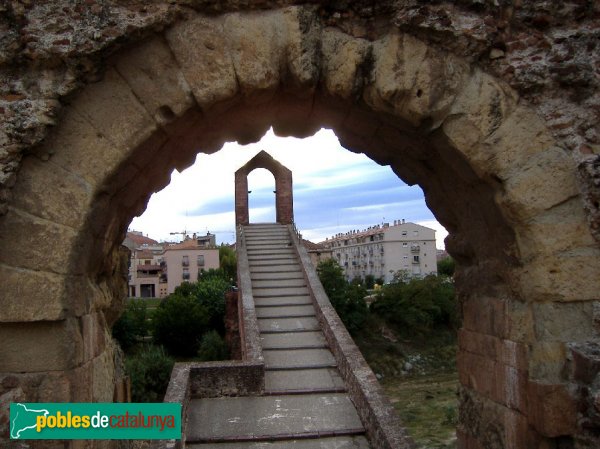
[265,368,345,394]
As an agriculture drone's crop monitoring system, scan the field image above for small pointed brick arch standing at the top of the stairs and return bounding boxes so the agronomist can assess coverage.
[235,151,294,225]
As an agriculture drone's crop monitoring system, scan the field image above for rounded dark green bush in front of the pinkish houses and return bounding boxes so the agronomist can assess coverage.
[152,290,210,357]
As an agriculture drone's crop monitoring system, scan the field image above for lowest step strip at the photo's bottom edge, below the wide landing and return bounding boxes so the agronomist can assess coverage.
[186,435,370,449]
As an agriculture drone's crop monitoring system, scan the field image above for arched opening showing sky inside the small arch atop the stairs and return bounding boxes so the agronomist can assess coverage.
[248,168,277,223]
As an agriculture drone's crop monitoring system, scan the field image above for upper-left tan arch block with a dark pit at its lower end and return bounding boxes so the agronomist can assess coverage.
[114,37,195,124]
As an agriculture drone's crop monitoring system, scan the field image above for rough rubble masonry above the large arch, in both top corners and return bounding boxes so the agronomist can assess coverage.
[0,0,600,233]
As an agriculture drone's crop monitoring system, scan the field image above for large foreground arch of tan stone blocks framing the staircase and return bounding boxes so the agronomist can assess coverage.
[0,7,600,448]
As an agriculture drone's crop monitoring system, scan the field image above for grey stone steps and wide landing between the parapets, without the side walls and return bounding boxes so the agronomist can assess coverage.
[186,224,370,449]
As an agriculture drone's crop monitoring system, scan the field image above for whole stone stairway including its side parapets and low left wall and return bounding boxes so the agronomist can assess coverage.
[162,223,413,449]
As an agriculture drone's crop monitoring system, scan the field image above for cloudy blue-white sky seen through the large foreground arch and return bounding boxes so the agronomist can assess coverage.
[129,129,448,249]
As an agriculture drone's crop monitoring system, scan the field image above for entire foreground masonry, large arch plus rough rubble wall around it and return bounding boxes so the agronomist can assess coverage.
[0,0,600,449]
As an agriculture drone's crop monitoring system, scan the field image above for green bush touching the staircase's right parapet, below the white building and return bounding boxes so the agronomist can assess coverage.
[317,259,369,334]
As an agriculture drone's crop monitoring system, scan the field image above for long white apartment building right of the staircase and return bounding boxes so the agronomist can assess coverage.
[322,220,437,282]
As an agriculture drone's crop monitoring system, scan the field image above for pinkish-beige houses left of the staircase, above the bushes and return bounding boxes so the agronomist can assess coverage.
[123,231,219,298]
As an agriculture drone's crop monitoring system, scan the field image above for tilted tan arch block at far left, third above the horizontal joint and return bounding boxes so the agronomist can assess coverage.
[12,157,92,228]
